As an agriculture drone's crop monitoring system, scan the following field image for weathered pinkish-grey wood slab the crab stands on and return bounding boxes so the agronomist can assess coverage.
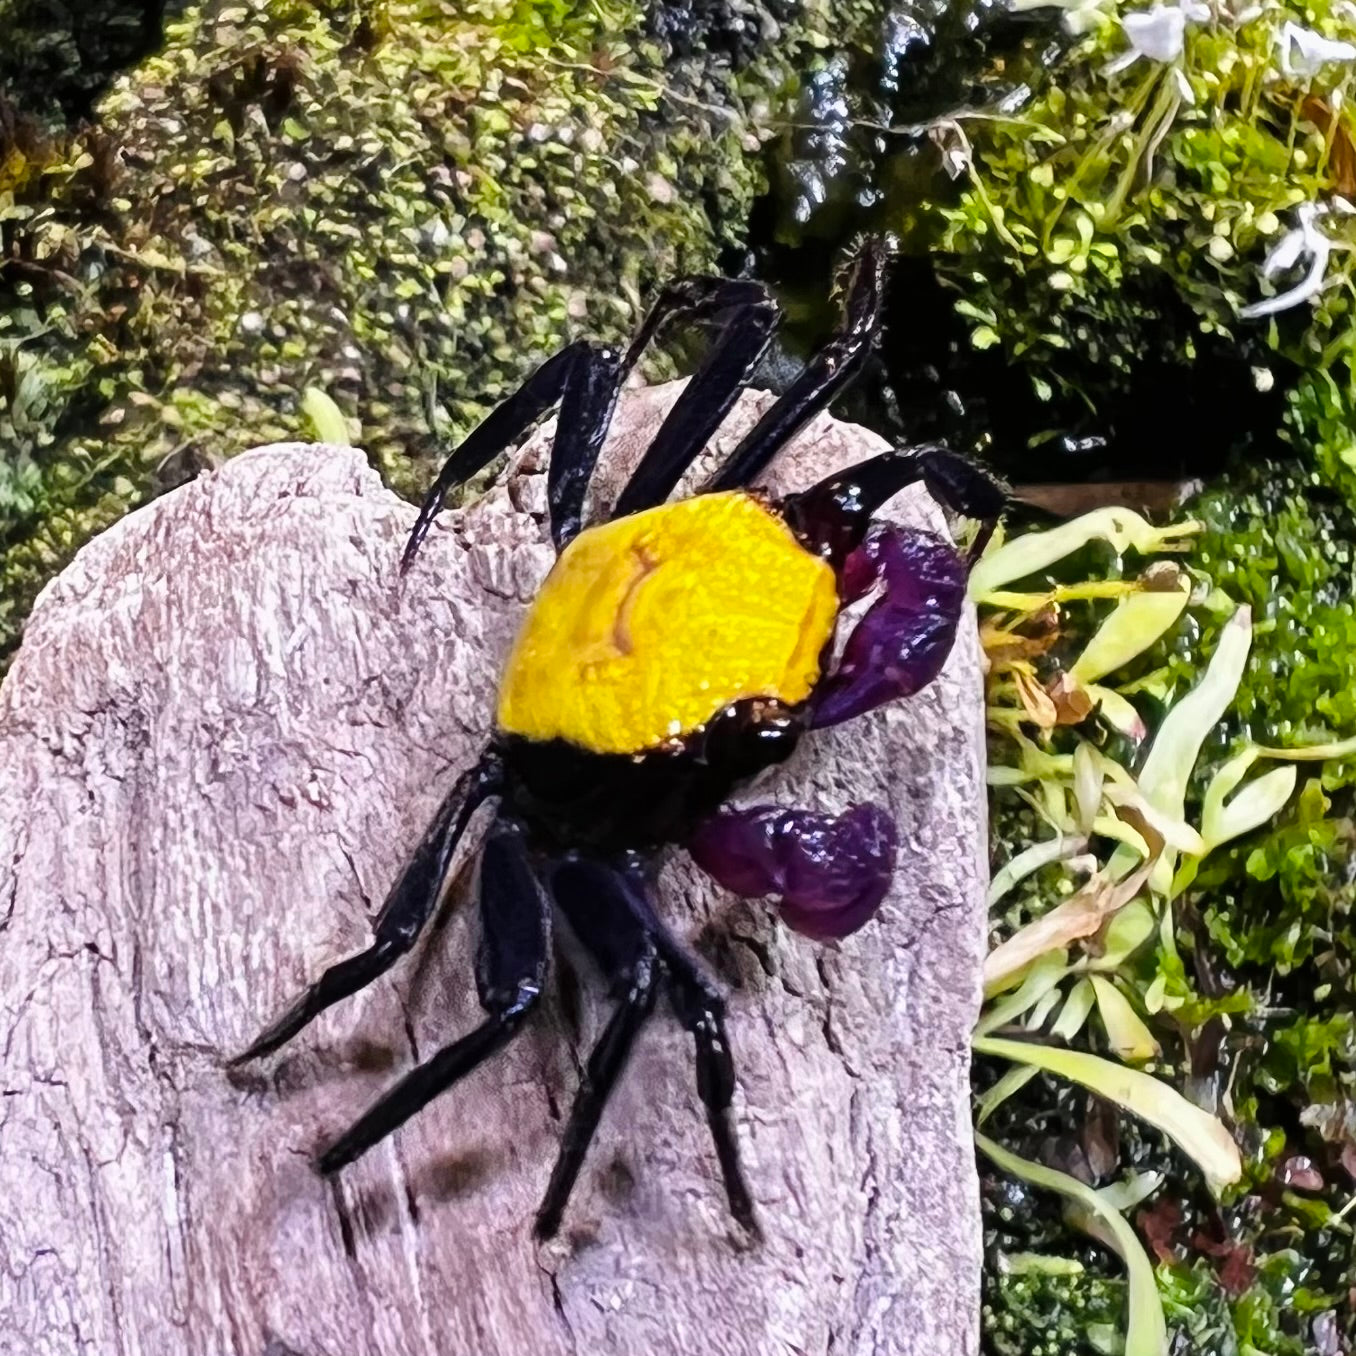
[0,386,984,1356]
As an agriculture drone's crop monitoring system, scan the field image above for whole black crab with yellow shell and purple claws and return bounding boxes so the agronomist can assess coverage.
[235,241,1005,1238]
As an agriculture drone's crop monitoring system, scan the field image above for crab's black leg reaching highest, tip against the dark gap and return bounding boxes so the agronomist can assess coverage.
[705,240,888,490]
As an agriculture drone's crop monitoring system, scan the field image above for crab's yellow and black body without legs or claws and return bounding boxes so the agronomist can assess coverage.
[495,490,839,850]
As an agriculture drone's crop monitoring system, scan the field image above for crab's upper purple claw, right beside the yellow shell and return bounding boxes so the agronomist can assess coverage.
[811,526,965,728]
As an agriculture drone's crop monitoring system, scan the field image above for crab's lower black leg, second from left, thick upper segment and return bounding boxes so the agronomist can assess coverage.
[319,816,551,1173]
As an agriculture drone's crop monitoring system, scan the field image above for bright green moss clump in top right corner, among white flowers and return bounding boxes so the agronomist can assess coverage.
[937,4,1356,500]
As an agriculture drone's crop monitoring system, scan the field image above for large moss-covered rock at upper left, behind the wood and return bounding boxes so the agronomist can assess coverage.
[0,0,876,667]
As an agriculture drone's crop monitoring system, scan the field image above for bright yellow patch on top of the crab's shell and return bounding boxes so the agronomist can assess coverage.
[498,490,838,754]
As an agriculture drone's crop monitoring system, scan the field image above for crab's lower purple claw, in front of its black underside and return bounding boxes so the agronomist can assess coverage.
[687,805,899,941]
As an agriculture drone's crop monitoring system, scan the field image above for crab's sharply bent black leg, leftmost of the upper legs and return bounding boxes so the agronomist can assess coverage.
[400,339,621,571]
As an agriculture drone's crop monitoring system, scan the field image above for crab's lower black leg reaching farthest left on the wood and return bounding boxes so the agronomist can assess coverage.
[231,755,500,1064]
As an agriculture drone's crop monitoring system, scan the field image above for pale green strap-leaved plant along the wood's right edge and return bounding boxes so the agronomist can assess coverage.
[971,509,1356,1356]
